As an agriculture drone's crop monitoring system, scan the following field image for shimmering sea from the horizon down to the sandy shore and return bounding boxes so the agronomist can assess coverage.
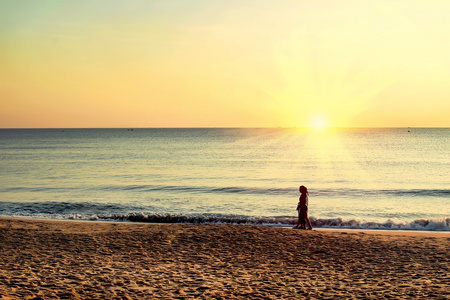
[0,128,450,230]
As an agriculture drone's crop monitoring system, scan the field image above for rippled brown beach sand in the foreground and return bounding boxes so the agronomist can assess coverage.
[0,219,450,299]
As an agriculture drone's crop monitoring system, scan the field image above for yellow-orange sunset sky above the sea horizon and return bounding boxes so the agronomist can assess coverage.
[0,0,450,128]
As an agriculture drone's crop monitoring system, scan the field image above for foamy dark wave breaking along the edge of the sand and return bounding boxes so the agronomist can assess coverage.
[0,201,450,231]
